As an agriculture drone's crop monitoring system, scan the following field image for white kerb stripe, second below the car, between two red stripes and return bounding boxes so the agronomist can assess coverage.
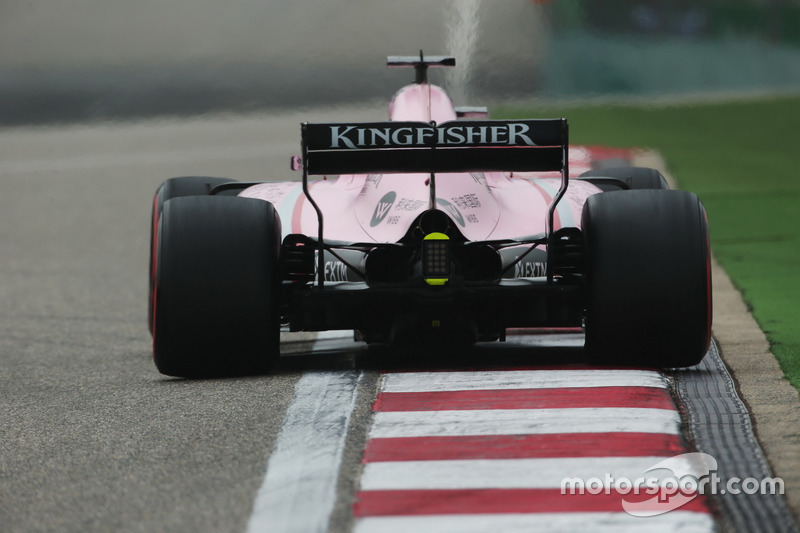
[369,407,681,439]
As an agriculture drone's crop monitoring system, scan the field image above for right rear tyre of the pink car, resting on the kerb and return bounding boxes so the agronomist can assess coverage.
[582,190,711,368]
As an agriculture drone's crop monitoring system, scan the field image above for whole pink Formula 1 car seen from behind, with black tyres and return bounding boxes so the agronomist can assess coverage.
[150,53,711,376]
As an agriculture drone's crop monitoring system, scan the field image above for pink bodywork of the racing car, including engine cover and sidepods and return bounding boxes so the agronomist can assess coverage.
[240,83,612,243]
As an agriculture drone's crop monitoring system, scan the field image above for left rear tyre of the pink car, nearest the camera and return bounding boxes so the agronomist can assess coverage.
[153,196,281,377]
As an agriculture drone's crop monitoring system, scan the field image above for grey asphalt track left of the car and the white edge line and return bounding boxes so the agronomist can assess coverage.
[0,109,378,532]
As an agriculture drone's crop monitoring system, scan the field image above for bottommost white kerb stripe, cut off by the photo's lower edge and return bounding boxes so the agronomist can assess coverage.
[354,511,716,533]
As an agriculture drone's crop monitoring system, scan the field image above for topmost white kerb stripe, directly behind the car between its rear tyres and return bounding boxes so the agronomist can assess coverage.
[383,370,668,392]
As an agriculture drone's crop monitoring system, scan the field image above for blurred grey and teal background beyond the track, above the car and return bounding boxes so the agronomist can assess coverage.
[0,0,800,126]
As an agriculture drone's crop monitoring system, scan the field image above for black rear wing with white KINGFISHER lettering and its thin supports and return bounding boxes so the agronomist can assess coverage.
[301,119,569,286]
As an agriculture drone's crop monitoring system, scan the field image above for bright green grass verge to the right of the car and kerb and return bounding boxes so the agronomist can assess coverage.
[500,96,800,390]
